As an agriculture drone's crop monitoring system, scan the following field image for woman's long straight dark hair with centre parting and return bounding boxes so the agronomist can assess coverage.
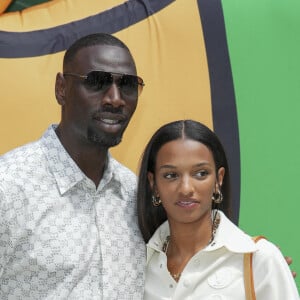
[137,120,232,243]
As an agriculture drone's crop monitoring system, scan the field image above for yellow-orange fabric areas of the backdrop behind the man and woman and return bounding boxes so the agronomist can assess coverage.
[0,0,212,171]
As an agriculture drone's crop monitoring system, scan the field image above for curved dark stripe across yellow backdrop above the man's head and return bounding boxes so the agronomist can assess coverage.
[0,0,174,58]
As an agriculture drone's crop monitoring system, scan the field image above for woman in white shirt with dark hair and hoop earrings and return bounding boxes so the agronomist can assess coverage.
[138,120,299,300]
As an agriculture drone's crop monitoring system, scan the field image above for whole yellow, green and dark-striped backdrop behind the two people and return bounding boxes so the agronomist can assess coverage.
[0,0,300,286]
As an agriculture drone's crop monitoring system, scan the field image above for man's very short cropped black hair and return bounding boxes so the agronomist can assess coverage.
[63,32,133,69]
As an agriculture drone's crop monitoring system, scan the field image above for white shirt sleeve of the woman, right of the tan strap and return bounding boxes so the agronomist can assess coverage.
[253,239,299,300]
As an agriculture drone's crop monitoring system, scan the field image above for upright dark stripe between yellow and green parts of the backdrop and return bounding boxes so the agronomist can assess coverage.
[198,0,240,224]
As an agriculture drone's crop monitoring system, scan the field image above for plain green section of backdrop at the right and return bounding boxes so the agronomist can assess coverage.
[222,0,300,288]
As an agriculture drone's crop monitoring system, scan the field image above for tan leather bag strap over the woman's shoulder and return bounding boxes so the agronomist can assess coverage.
[244,235,265,300]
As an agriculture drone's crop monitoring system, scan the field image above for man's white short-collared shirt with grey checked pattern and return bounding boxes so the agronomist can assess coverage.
[0,125,145,300]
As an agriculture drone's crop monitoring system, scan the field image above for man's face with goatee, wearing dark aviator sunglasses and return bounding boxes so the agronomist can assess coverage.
[57,45,138,147]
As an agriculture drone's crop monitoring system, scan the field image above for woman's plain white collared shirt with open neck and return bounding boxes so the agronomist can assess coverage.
[144,212,299,300]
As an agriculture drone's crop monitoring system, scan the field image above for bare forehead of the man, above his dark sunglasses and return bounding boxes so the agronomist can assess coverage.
[68,45,136,75]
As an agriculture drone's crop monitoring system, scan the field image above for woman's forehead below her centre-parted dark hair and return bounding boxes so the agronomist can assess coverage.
[156,139,215,167]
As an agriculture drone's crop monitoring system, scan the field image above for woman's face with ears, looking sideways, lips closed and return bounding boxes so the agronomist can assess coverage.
[148,139,225,223]
